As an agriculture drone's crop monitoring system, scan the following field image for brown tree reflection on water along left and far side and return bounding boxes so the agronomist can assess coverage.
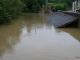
[0,13,51,57]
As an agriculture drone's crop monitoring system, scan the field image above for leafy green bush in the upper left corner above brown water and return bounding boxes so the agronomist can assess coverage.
[0,0,25,23]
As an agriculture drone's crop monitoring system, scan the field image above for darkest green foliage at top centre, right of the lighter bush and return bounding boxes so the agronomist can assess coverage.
[21,0,45,13]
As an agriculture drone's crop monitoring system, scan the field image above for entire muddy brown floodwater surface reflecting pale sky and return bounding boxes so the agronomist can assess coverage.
[0,13,80,60]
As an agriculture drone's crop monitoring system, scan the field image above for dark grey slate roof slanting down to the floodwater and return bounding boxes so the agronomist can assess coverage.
[46,12,78,28]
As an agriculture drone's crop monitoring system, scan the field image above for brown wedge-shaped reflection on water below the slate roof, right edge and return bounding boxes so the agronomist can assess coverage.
[57,28,80,42]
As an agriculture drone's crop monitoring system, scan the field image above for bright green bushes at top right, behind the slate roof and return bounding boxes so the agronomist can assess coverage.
[47,0,73,10]
